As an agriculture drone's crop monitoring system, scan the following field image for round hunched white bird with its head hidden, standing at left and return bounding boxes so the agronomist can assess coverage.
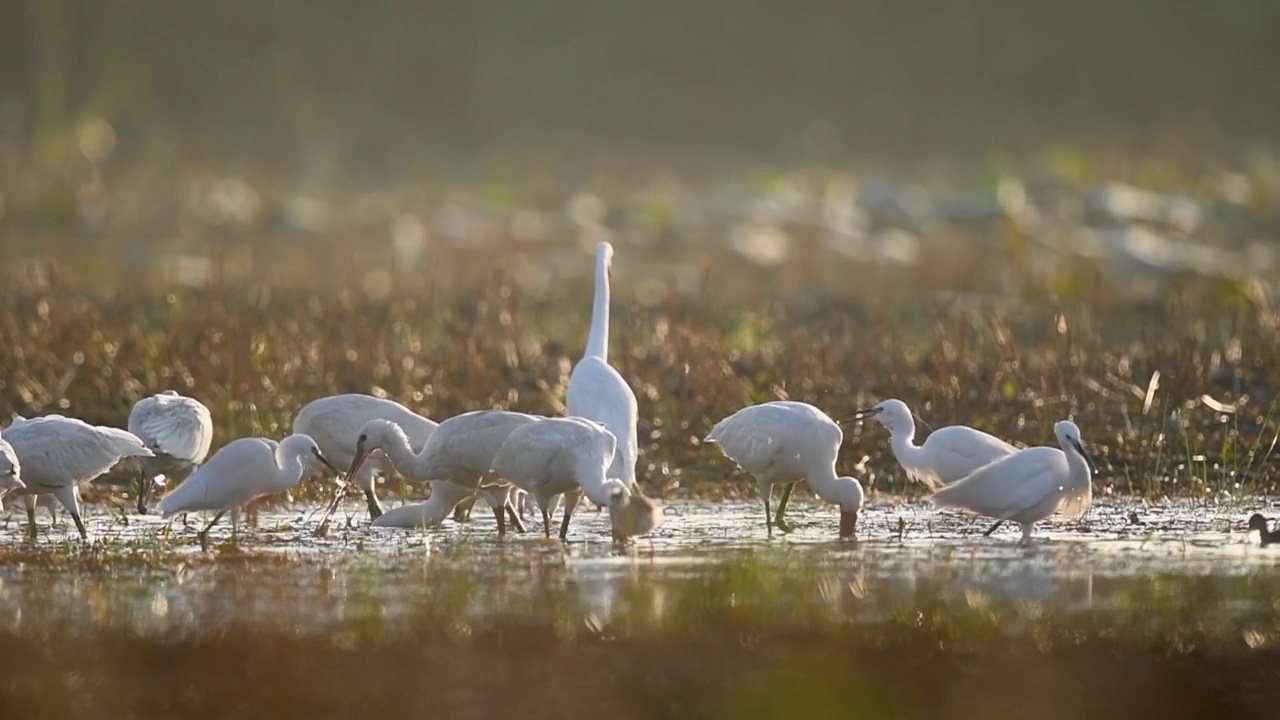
[129,389,214,515]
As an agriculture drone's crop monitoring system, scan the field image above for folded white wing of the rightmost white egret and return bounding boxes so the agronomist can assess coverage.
[933,447,1066,518]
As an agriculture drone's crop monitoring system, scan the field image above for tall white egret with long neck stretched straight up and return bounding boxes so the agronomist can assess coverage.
[564,242,640,502]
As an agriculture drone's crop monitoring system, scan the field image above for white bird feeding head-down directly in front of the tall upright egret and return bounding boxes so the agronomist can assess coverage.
[481,418,628,539]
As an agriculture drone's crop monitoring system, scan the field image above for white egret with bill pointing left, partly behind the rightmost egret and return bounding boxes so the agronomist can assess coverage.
[852,400,1018,536]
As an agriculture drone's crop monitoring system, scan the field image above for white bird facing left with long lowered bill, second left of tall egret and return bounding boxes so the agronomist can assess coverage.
[347,410,541,536]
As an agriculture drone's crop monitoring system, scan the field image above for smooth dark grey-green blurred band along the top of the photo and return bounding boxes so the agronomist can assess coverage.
[0,0,1280,161]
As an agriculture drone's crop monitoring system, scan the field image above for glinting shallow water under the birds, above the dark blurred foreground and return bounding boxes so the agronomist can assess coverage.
[0,489,1280,634]
